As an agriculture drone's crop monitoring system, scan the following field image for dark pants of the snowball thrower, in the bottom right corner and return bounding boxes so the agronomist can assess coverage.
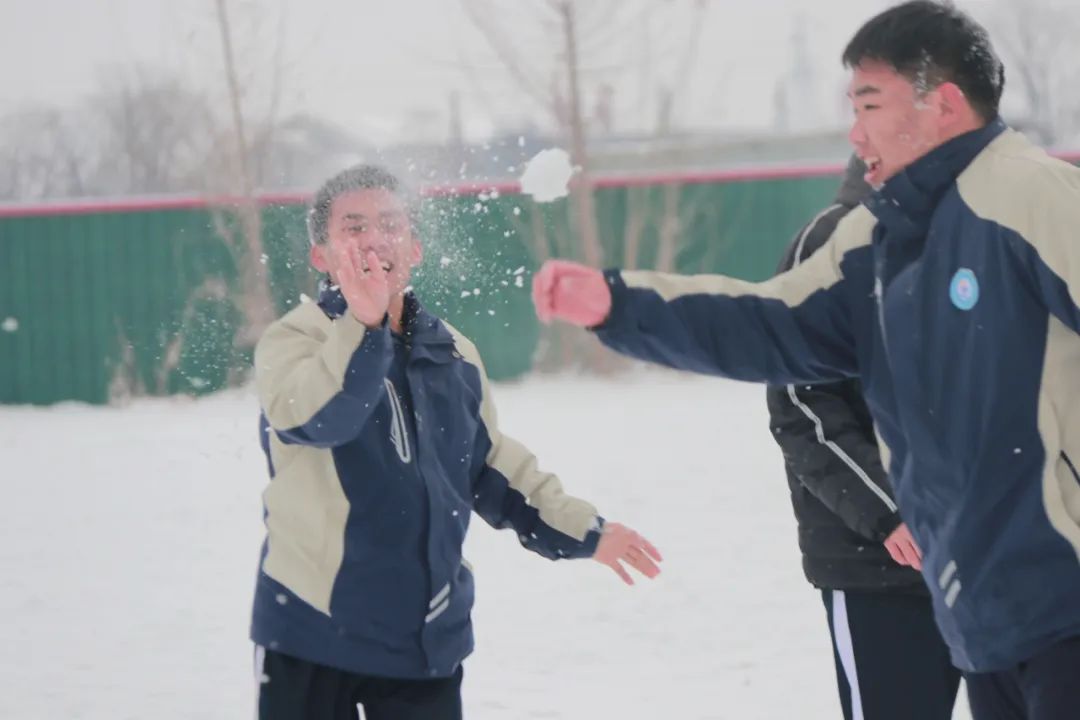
[964,637,1080,720]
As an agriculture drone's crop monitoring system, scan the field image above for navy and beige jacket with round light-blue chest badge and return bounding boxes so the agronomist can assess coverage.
[597,121,1080,671]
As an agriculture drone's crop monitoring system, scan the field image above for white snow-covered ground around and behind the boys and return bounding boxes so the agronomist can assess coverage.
[0,371,968,720]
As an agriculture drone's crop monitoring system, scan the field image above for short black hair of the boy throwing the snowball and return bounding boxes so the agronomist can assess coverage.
[843,0,1005,122]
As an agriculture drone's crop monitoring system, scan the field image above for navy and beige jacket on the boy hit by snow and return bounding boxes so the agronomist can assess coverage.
[252,288,602,678]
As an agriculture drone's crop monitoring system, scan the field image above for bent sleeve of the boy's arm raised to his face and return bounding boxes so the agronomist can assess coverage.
[255,308,393,448]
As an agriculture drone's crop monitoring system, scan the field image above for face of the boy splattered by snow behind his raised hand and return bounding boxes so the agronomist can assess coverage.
[311,188,422,295]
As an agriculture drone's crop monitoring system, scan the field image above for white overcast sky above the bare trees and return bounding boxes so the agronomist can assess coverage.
[0,0,1054,142]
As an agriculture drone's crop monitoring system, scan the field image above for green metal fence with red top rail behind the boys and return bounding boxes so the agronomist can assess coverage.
[0,168,837,405]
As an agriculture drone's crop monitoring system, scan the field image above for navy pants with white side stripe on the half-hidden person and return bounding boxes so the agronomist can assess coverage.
[822,590,963,720]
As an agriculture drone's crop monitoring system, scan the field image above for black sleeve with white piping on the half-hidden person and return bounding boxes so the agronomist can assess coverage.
[766,381,901,542]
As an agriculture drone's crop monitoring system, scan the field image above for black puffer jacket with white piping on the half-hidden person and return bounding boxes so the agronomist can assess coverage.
[767,159,927,594]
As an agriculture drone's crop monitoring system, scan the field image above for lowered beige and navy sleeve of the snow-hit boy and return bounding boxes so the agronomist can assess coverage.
[459,334,604,560]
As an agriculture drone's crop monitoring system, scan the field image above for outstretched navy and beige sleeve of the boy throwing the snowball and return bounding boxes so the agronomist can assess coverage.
[595,210,873,384]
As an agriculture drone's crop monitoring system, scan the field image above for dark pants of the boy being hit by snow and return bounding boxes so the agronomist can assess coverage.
[255,648,461,720]
